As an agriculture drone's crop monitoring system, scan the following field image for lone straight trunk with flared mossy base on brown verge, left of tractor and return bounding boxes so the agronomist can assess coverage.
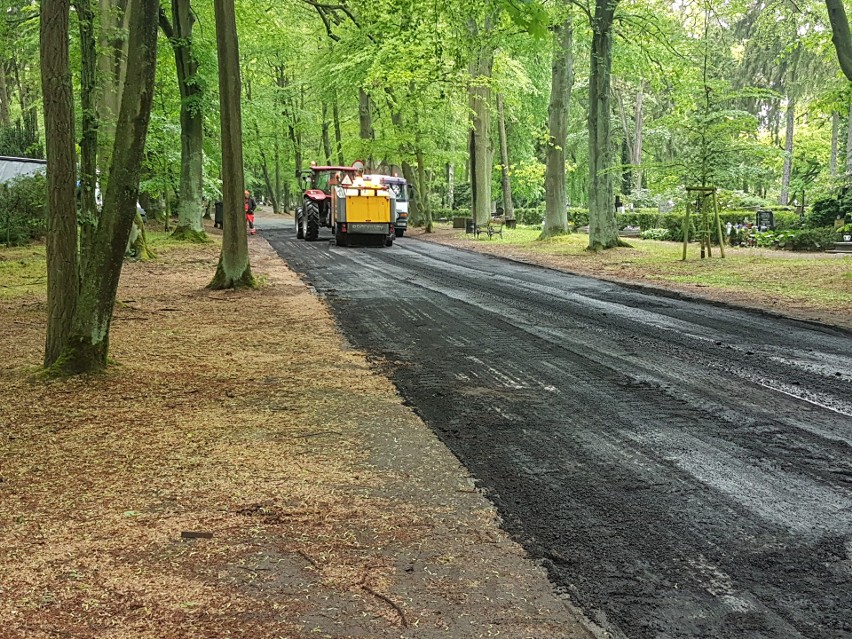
[209,0,255,289]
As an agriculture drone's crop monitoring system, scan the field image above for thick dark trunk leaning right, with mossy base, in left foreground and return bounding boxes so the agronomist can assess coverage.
[54,0,159,373]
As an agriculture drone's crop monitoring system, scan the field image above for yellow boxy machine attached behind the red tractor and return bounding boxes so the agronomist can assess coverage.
[331,177,396,246]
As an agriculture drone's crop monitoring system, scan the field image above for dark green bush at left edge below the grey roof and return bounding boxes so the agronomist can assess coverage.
[0,173,47,246]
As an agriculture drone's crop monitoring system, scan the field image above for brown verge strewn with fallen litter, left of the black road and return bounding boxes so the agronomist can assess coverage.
[0,237,591,639]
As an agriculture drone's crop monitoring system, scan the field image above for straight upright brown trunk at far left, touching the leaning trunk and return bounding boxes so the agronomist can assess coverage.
[39,0,79,367]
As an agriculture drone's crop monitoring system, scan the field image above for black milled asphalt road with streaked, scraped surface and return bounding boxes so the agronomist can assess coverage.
[261,224,852,639]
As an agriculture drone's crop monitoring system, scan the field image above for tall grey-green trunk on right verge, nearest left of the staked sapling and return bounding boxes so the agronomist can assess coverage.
[588,0,623,251]
